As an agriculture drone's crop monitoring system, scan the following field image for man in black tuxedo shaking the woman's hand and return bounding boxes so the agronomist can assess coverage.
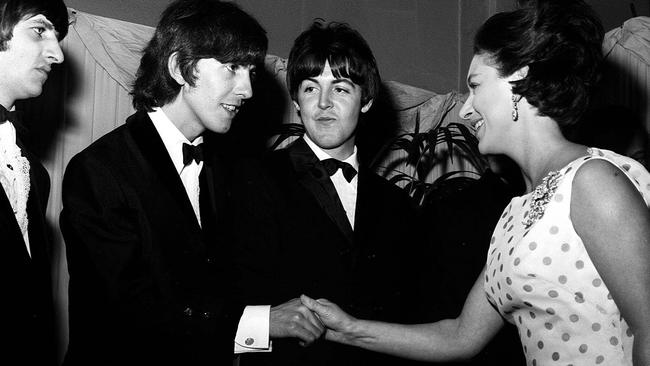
[61,0,320,366]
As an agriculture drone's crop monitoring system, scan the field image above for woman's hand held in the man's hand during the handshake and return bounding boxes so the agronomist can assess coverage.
[300,295,356,342]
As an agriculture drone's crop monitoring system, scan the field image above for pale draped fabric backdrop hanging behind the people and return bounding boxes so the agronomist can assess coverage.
[18,9,650,364]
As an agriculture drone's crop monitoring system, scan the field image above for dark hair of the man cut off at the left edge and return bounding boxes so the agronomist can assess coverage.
[0,0,68,51]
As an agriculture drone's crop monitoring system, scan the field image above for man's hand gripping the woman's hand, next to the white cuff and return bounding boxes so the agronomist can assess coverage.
[269,299,325,346]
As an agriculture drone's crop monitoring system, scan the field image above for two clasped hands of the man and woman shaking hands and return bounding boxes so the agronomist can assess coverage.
[269,295,356,347]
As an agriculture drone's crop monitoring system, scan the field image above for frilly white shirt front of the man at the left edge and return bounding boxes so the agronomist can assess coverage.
[0,121,32,257]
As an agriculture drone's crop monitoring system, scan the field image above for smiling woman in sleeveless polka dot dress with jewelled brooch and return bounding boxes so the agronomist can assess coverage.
[302,0,650,366]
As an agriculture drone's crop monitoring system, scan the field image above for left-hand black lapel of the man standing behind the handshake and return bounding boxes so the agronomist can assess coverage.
[287,139,354,245]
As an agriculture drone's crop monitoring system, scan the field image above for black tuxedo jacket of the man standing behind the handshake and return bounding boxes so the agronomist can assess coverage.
[233,139,418,366]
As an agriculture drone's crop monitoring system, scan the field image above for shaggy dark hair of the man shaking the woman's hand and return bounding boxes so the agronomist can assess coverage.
[131,0,268,111]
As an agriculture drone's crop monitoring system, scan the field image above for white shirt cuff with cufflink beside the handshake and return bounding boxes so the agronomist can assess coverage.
[235,305,271,353]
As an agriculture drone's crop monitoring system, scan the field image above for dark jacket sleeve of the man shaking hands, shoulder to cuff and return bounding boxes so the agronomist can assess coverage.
[60,155,241,364]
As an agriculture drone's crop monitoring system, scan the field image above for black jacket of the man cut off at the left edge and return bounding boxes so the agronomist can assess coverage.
[0,135,56,365]
